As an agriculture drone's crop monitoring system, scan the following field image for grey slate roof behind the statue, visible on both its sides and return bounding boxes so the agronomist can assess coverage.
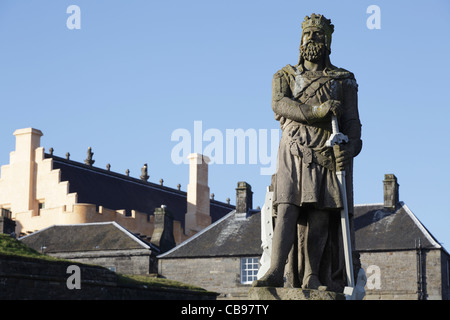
[158,202,445,259]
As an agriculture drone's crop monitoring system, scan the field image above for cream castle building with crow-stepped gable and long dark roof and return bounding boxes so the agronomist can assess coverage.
[0,128,234,248]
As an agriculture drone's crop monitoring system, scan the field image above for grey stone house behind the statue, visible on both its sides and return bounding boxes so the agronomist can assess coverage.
[158,175,450,300]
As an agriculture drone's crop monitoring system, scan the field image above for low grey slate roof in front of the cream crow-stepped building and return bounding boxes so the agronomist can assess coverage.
[19,222,159,253]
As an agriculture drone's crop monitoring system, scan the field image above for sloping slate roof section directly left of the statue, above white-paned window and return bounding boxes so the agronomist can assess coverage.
[158,211,262,259]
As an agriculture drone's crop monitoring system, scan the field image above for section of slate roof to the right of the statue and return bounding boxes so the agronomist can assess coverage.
[354,202,442,251]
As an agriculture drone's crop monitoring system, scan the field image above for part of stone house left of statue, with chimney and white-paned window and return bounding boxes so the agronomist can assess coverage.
[158,182,262,299]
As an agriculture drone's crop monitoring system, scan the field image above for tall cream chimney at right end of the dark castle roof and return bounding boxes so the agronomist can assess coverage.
[184,153,211,236]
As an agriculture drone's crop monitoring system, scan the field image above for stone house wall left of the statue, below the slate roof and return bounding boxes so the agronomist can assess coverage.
[158,257,255,299]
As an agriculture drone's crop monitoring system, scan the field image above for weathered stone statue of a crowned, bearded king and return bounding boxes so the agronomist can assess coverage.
[253,14,362,292]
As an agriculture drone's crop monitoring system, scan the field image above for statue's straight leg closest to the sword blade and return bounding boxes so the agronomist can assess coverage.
[302,209,330,289]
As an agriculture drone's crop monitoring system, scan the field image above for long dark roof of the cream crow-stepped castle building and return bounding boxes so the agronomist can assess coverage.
[45,154,235,228]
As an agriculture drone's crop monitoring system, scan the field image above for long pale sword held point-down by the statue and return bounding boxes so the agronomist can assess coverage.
[326,115,355,299]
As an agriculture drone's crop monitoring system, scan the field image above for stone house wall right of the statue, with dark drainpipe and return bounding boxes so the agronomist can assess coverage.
[361,250,447,300]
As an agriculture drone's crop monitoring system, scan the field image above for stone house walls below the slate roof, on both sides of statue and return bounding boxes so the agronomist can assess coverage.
[158,250,450,300]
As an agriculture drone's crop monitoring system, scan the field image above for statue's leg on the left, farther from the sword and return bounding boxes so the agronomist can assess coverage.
[253,204,300,287]
